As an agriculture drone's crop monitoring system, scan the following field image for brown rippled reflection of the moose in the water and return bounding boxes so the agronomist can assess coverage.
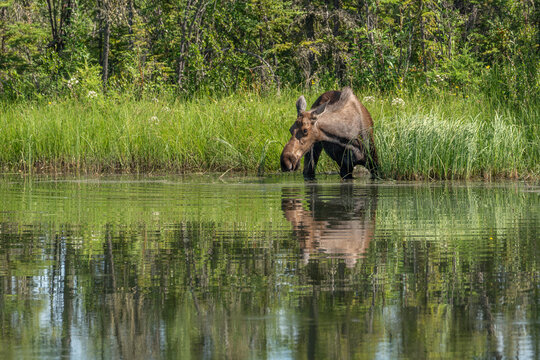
[281,183,377,267]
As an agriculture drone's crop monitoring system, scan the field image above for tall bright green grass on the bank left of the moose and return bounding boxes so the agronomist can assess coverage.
[0,94,294,172]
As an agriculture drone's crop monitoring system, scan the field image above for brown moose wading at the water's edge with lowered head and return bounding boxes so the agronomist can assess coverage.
[280,87,379,180]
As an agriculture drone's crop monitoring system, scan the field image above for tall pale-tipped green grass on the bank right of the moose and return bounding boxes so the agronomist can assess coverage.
[372,91,540,179]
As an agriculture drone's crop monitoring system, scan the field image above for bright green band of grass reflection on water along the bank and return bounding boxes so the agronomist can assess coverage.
[0,177,539,253]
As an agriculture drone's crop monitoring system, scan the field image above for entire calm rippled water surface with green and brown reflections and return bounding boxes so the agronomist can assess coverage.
[0,176,540,359]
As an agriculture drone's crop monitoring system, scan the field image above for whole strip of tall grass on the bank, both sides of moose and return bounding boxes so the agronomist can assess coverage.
[0,90,540,179]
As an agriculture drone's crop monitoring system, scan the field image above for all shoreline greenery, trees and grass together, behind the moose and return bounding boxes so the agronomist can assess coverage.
[0,0,540,179]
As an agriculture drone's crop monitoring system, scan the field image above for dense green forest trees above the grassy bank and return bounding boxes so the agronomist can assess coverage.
[0,0,540,102]
